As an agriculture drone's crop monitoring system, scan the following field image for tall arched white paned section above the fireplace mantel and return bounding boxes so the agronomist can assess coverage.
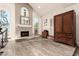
[21,7,29,25]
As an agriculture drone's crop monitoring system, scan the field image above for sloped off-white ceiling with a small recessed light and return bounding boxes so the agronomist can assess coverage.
[30,3,75,16]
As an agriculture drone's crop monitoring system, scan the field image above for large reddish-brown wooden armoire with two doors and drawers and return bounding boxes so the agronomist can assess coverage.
[54,10,76,46]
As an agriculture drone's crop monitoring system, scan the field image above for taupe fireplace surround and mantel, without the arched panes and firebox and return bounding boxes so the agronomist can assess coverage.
[15,3,33,39]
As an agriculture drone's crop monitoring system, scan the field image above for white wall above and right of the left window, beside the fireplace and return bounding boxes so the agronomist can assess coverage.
[0,3,15,39]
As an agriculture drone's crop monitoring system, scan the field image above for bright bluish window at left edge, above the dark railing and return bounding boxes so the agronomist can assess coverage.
[0,10,10,27]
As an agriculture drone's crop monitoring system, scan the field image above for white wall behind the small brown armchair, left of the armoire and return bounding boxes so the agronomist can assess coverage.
[41,15,54,36]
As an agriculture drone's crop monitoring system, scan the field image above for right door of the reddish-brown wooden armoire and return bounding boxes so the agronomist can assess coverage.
[63,12,73,33]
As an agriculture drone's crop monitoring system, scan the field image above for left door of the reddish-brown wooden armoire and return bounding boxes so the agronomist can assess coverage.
[54,15,62,33]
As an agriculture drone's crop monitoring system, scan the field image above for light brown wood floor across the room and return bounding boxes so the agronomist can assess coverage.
[2,38,75,56]
